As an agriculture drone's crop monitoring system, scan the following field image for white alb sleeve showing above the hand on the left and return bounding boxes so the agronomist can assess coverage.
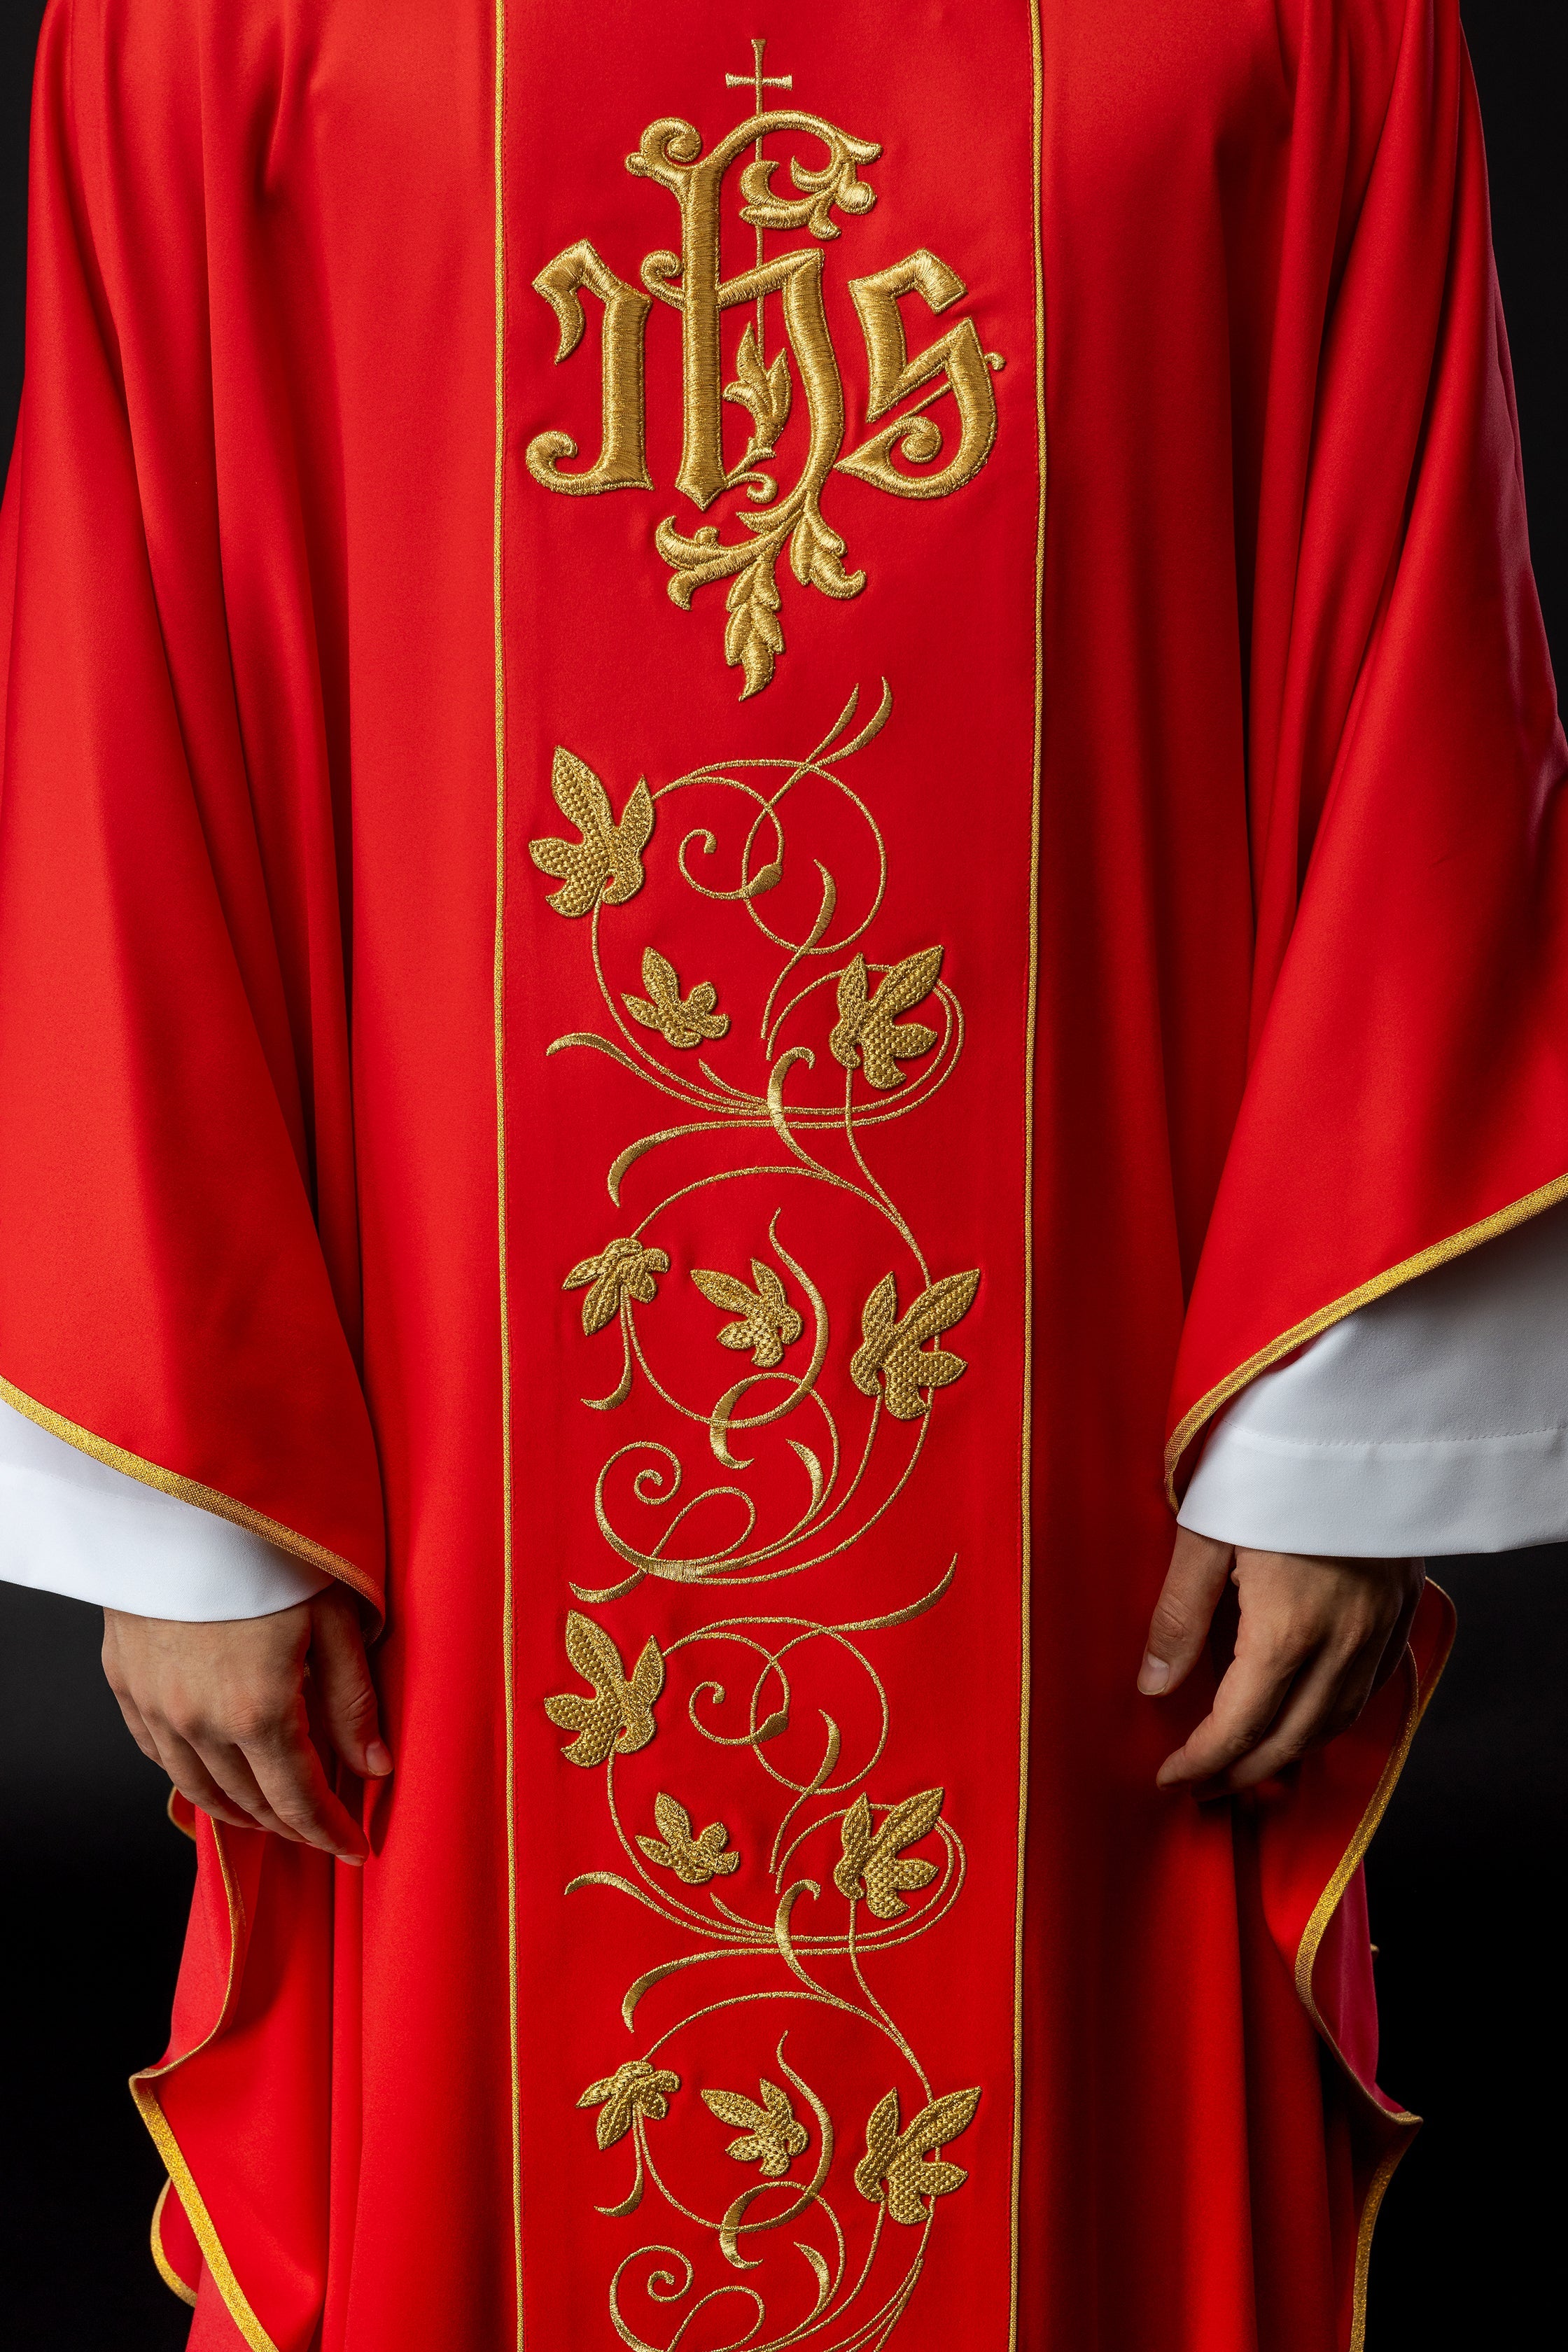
[0,1399,332,1623]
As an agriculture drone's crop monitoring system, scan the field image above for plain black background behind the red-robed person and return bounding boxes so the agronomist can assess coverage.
[0,0,1568,2352]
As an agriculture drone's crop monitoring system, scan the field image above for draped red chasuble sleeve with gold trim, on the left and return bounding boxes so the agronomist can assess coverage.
[0,0,383,1606]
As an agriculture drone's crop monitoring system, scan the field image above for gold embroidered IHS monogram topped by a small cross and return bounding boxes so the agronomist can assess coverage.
[526,40,1002,699]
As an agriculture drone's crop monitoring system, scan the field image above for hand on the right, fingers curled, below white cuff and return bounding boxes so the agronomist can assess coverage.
[1138,1527,1424,1797]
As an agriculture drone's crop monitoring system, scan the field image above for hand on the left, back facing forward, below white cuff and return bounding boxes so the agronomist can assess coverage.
[104,1586,393,1863]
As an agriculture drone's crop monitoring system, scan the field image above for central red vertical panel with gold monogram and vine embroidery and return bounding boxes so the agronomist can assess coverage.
[498,0,1039,2352]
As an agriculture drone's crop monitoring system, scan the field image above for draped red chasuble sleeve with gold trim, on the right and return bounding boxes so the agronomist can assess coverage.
[1166,0,1568,1498]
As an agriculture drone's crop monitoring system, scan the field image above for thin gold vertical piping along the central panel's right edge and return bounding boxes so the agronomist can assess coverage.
[1009,0,1046,2352]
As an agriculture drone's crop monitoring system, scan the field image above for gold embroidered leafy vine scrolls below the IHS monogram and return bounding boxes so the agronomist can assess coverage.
[529,687,983,2352]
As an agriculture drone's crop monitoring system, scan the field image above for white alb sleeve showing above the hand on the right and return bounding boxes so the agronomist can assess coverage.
[1180,1202,1568,1560]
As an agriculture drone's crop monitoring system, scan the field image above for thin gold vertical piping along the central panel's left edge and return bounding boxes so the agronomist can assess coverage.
[491,0,522,2352]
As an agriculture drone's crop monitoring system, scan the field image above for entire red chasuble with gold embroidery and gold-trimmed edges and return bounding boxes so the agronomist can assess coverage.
[0,0,1568,2352]
